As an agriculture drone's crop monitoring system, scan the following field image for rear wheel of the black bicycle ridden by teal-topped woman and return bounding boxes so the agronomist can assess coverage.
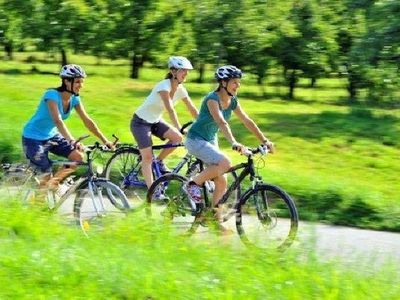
[147,173,195,233]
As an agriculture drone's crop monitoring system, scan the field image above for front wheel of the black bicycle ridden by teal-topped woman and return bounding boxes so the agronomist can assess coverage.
[236,184,298,250]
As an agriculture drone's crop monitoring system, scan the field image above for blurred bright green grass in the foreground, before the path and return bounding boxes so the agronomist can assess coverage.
[0,198,400,299]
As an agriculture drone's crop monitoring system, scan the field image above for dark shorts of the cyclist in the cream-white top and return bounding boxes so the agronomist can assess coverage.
[131,114,170,149]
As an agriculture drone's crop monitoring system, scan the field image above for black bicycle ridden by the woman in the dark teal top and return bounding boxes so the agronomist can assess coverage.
[147,146,298,250]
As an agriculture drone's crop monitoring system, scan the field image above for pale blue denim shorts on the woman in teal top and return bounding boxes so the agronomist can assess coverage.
[185,138,225,165]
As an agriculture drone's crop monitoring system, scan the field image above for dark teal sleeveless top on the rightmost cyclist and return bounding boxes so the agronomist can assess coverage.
[187,92,238,143]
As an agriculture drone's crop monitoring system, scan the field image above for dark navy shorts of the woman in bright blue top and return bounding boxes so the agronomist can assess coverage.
[22,134,74,172]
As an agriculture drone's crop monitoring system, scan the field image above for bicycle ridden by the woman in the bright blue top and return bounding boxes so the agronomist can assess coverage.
[2,138,130,234]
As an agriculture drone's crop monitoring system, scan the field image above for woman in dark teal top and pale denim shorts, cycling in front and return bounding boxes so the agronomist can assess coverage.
[185,65,274,225]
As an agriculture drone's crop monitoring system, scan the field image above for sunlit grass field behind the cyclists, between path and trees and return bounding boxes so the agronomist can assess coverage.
[0,54,400,231]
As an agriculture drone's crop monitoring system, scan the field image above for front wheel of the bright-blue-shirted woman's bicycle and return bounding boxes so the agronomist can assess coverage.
[74,179,130,235]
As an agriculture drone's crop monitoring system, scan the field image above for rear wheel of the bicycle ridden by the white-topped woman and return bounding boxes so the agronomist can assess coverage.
[103,147,147,206]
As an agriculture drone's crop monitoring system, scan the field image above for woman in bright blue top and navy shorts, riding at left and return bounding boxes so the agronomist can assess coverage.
[22,64,114,189]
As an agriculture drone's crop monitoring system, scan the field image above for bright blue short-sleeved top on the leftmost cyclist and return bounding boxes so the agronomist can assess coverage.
[22,89,80,141]
